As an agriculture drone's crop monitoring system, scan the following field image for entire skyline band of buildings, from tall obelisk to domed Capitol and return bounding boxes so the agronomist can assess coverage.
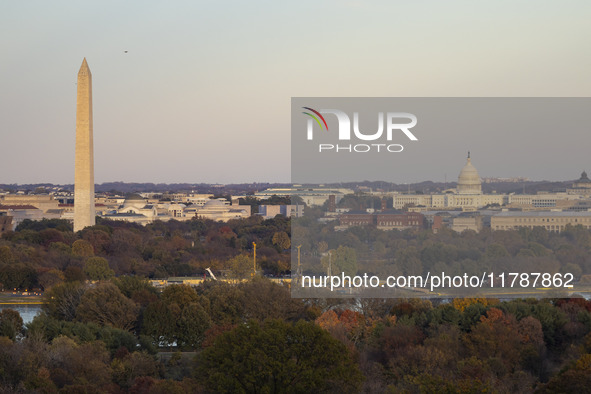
[0,59,591,237]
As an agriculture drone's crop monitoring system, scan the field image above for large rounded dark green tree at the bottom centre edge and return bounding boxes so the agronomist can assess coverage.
[197,320,363,392]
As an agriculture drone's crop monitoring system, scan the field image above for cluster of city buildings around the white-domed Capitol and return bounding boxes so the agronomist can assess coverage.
[326,153,591,232]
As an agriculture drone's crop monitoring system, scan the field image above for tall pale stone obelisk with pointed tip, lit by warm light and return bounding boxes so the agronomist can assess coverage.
[74,58,95,232]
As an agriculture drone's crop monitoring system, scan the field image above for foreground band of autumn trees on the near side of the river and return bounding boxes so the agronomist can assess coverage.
[0,276,591,393]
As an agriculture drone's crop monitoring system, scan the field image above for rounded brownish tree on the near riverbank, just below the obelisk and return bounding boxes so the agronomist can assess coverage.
[77,282,139,330]
